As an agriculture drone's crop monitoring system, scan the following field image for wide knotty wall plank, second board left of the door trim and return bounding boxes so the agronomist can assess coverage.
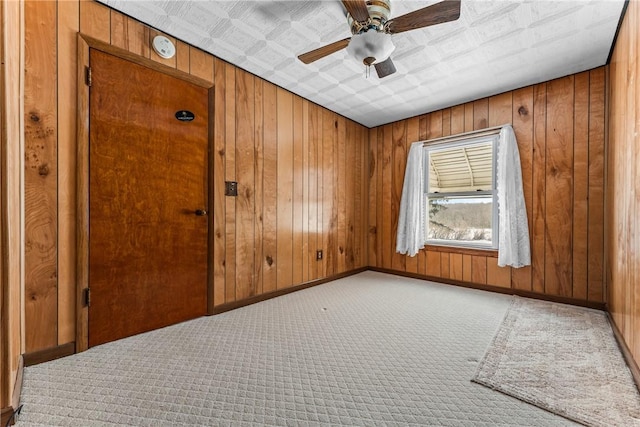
[24,1,58,352]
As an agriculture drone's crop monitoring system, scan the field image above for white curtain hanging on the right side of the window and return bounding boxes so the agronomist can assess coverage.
[497,125,531,268]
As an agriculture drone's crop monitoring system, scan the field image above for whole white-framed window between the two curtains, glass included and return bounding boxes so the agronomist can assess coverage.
[425,135,499,249]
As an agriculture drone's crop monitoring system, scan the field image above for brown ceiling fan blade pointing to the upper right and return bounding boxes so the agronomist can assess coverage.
[385,0,460,34]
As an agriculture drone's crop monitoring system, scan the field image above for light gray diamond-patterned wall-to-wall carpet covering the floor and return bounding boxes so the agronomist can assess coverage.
[17,272,575,427]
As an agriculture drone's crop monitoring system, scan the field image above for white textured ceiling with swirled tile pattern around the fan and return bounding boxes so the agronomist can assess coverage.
[100,0,624,127]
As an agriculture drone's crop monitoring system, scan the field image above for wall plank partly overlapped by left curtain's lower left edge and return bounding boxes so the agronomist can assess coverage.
[390,120,404,271]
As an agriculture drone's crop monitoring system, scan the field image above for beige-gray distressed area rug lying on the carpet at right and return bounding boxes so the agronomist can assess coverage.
[474,298,640,426]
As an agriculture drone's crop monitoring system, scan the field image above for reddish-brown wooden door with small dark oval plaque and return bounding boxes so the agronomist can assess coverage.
[89,49,208,346]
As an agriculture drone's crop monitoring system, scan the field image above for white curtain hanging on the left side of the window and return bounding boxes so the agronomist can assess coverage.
[396,141,425,256]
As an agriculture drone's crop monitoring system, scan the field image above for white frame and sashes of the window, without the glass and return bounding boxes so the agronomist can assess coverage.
[423,133,500,251]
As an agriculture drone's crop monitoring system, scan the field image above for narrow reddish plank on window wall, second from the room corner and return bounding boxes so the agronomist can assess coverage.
[379,124,395,268]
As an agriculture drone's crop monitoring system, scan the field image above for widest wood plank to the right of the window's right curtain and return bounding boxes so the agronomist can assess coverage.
[544,76,574,297]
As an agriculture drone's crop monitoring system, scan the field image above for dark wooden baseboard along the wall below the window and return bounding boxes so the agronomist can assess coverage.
[369,267,606,311]
